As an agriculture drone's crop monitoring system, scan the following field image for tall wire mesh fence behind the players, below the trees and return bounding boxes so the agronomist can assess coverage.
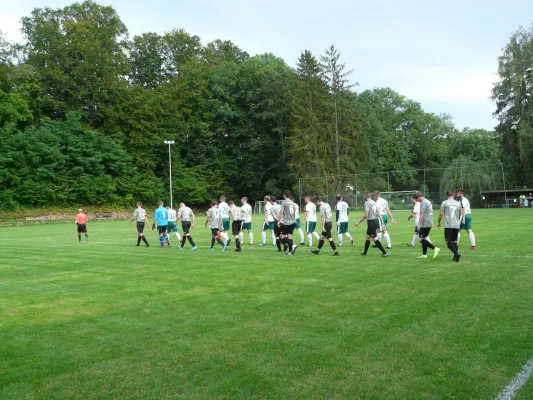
[298,162,507,209]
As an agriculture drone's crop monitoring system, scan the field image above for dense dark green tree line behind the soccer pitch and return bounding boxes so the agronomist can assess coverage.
[0,1,533,209]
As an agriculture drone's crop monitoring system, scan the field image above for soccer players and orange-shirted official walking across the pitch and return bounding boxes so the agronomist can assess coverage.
[76,186,476,262]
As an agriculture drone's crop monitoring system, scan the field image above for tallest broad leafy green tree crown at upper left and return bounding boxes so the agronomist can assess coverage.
[22,1,128,127]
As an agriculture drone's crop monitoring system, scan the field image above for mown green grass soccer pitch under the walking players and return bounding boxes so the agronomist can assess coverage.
[0,209,533,400]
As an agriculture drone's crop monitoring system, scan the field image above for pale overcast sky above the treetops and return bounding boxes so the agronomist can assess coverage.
[0,0,533,129]
